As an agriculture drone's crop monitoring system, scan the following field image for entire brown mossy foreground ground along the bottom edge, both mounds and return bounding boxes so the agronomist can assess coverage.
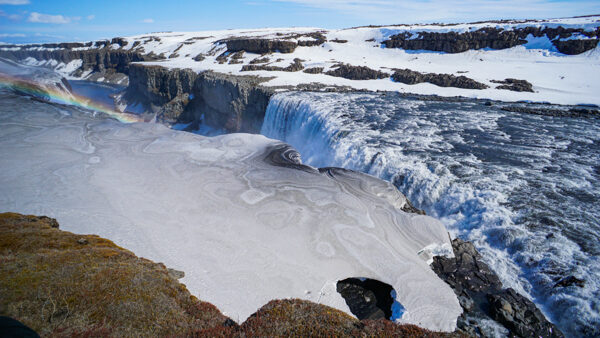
[0,213,461,337]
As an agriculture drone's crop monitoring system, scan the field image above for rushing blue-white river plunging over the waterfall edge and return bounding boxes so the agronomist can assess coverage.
[262,93,600,335]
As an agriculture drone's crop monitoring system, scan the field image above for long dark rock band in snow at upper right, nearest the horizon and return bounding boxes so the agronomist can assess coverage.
[382,27,599,55]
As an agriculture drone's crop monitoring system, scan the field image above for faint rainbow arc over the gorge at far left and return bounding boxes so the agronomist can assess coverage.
[0,73,144,123]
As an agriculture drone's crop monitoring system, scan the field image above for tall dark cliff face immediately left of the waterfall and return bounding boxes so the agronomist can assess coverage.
[124,64,273,132]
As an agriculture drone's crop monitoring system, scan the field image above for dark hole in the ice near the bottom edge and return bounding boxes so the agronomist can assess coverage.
[337,277,405,320]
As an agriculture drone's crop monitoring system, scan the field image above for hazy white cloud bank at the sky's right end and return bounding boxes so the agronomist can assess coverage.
[272,0,600,24]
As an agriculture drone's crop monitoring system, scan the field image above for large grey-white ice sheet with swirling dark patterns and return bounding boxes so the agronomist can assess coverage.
[0,93,461,330]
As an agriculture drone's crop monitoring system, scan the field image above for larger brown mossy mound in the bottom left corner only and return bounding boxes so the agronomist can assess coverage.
[0,213,227,337]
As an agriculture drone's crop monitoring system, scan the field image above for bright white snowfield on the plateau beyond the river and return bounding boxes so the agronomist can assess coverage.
[21,16,600,105]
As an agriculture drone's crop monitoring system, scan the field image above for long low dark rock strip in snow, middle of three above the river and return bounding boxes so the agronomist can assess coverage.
[392,69,488,89]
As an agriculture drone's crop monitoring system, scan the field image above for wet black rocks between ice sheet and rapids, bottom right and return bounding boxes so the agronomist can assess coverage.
[431,239,563,337]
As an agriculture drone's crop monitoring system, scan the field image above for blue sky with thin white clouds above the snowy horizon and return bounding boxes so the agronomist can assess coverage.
[0,0,600,43]
